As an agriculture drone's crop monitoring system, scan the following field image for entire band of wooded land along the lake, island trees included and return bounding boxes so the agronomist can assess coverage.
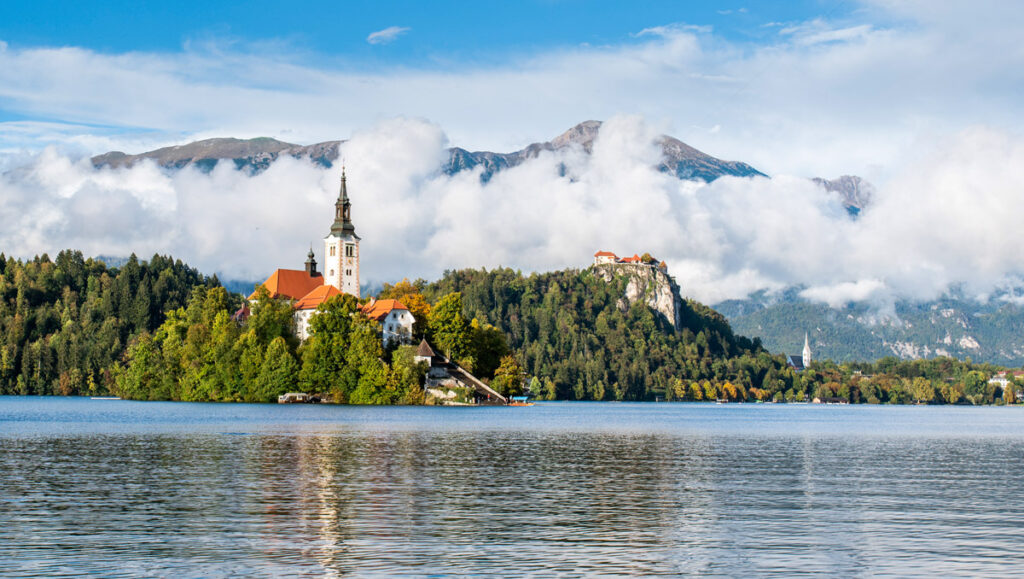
[0,251,1024,404]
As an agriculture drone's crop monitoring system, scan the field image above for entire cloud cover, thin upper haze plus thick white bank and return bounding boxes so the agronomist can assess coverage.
[0,0,1024,304]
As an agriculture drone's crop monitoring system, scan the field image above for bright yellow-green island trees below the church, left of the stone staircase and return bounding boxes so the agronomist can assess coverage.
[116,288,424,404]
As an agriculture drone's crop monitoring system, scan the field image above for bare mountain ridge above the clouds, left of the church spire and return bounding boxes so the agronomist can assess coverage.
[92,137,342,172]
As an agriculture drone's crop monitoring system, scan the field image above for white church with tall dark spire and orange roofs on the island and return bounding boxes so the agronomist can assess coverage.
[245,168,416,346]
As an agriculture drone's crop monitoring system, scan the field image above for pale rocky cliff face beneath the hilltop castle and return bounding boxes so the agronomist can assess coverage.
[593,263,683,331]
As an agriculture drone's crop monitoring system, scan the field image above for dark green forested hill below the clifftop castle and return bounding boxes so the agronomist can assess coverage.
[423,270,778,400]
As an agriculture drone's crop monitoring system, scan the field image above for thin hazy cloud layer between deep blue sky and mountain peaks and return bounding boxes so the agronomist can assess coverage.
[0,2,1024,180]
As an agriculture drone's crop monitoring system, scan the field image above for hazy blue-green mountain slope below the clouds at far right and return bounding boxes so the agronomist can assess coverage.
[715,288,1024,366]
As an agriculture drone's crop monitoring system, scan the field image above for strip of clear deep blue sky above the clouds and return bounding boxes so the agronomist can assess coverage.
[0,0,852,66]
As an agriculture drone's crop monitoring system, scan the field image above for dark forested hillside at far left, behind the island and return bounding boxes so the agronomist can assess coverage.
[0,251,218,395]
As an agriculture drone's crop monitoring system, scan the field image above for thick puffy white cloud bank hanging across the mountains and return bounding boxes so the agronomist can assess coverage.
[0,117,1024,304]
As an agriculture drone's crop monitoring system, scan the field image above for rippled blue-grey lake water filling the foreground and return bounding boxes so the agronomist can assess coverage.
[0,397,1024,577]
